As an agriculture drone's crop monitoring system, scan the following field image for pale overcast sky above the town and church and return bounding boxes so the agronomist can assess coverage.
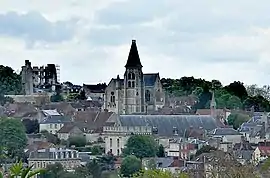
[0,0,270,85]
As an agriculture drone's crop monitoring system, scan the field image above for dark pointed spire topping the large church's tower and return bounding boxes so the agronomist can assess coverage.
[125,40,142,68]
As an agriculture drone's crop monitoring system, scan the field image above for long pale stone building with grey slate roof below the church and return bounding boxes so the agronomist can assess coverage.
[103,115,221,155]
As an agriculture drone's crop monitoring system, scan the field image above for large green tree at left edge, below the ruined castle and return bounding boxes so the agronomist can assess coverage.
[0,118,27,158]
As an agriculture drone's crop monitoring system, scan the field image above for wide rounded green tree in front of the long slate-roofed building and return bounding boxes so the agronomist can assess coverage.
[123,135,157,159]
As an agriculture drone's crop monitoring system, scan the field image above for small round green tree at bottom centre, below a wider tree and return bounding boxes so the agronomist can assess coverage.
[120,155,141,177]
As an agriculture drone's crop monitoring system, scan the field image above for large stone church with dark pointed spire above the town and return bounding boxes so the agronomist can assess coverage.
[104,40,165,114]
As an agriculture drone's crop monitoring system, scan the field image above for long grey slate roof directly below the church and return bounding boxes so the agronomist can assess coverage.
[119,115,220,136]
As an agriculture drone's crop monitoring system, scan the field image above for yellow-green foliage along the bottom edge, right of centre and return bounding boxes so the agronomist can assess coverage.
[132,170,189,178]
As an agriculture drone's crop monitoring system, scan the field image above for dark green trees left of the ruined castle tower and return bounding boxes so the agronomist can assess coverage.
[0,65,22,95]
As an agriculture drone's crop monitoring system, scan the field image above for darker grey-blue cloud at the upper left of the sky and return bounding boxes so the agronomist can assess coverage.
[0,12,76,42]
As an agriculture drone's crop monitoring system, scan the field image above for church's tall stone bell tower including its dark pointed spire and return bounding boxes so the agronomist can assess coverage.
[124,40,145,114]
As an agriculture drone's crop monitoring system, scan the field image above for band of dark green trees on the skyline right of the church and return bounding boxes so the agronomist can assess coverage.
[161,77,270,111]
